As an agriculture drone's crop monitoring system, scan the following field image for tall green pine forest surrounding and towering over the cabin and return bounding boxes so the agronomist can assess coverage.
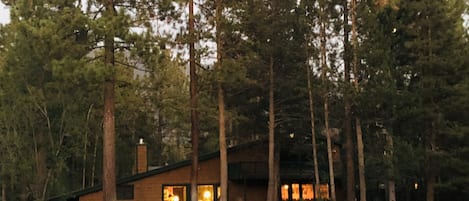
[0,0,469,201]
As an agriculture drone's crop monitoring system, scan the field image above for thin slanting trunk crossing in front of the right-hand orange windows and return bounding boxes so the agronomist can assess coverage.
[306,51,320,199]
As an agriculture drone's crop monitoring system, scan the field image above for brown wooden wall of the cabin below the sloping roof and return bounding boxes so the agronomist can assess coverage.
[79,141,267,201]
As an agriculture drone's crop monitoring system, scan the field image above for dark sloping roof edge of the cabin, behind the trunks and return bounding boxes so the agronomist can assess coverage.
[47,140,264,201]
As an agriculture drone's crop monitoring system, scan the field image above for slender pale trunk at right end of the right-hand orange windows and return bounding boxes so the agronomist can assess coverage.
[320,2,336,201]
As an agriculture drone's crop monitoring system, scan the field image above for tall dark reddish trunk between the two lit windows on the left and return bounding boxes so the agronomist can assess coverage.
[189,0,199,200]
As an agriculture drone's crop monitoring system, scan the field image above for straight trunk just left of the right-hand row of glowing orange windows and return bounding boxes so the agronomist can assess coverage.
[267,56,277,201]
